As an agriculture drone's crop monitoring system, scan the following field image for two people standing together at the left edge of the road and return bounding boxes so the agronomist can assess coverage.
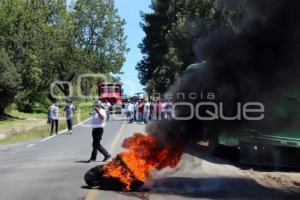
[48,100,76,135]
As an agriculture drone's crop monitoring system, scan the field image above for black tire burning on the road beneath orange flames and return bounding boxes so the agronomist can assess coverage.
[84,165,144,191]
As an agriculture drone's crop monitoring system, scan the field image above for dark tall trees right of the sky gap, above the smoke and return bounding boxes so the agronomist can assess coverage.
[136,0,247,94]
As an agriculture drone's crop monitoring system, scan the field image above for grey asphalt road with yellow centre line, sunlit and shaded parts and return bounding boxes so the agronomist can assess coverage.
[0,115,299,200]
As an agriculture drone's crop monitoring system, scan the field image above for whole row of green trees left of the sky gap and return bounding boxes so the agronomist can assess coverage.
[0,0,128,115]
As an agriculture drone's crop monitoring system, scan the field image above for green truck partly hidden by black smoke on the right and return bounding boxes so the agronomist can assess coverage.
[183,63,300,167]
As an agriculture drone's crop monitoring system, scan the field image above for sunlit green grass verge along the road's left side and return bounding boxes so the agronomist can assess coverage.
[0,105,92,144]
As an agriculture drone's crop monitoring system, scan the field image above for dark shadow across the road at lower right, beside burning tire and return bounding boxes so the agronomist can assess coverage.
[81,177,299,200]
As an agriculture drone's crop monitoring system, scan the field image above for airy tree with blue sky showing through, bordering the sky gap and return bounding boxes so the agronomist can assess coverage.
[74,0,129,73]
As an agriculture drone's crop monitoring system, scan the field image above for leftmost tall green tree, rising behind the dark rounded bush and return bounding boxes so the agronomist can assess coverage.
[0,0,44,112]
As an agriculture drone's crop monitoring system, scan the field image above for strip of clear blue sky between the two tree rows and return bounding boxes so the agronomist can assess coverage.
[115,0,151,95]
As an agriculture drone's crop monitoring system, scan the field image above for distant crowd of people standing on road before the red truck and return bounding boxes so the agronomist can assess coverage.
[125,99,172,124]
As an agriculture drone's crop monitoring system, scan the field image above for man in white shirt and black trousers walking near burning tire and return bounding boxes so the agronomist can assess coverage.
[88,101,111,162]
